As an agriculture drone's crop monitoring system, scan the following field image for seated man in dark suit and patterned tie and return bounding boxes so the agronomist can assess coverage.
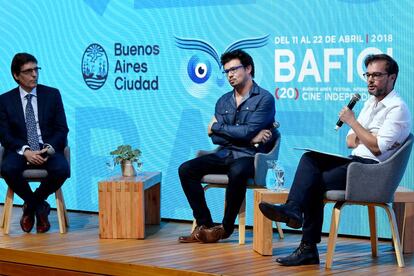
[0,53,70,233]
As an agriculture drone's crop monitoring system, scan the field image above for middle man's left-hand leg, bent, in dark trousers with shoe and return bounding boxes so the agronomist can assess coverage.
[178,154,227,242]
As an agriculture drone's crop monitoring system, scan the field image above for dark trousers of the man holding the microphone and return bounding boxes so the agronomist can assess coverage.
[288,152,378,243]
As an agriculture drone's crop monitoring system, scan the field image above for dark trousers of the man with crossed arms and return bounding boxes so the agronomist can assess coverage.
[178,154,254,234]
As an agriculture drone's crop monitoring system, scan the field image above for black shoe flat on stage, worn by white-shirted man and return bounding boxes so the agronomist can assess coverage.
[276,242,319,266]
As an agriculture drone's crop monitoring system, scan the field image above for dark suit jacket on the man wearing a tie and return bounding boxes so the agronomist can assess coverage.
[0,84,69,151]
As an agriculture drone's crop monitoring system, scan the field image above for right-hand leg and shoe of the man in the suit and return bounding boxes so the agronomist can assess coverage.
[34,152,70,233]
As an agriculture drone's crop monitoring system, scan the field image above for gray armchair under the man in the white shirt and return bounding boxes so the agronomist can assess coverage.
[325,134,413,268]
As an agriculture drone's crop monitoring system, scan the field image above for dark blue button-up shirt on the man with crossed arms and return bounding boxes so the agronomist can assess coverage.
[211,82,276,159]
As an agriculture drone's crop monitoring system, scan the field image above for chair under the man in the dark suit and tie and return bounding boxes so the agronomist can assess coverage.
[0,146,70,234]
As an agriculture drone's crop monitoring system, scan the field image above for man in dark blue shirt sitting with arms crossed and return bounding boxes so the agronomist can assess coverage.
[178,50,275,243]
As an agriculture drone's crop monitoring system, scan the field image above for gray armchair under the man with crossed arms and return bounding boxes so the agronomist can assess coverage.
[193,129,283,244]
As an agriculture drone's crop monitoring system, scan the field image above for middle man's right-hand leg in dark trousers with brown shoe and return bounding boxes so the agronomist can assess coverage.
[198,157,254,242]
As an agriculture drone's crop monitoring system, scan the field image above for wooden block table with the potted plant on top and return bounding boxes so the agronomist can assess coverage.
[98,172,161,239]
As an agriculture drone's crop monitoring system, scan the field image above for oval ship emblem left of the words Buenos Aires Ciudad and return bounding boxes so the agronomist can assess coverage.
[82,43,109,90]
